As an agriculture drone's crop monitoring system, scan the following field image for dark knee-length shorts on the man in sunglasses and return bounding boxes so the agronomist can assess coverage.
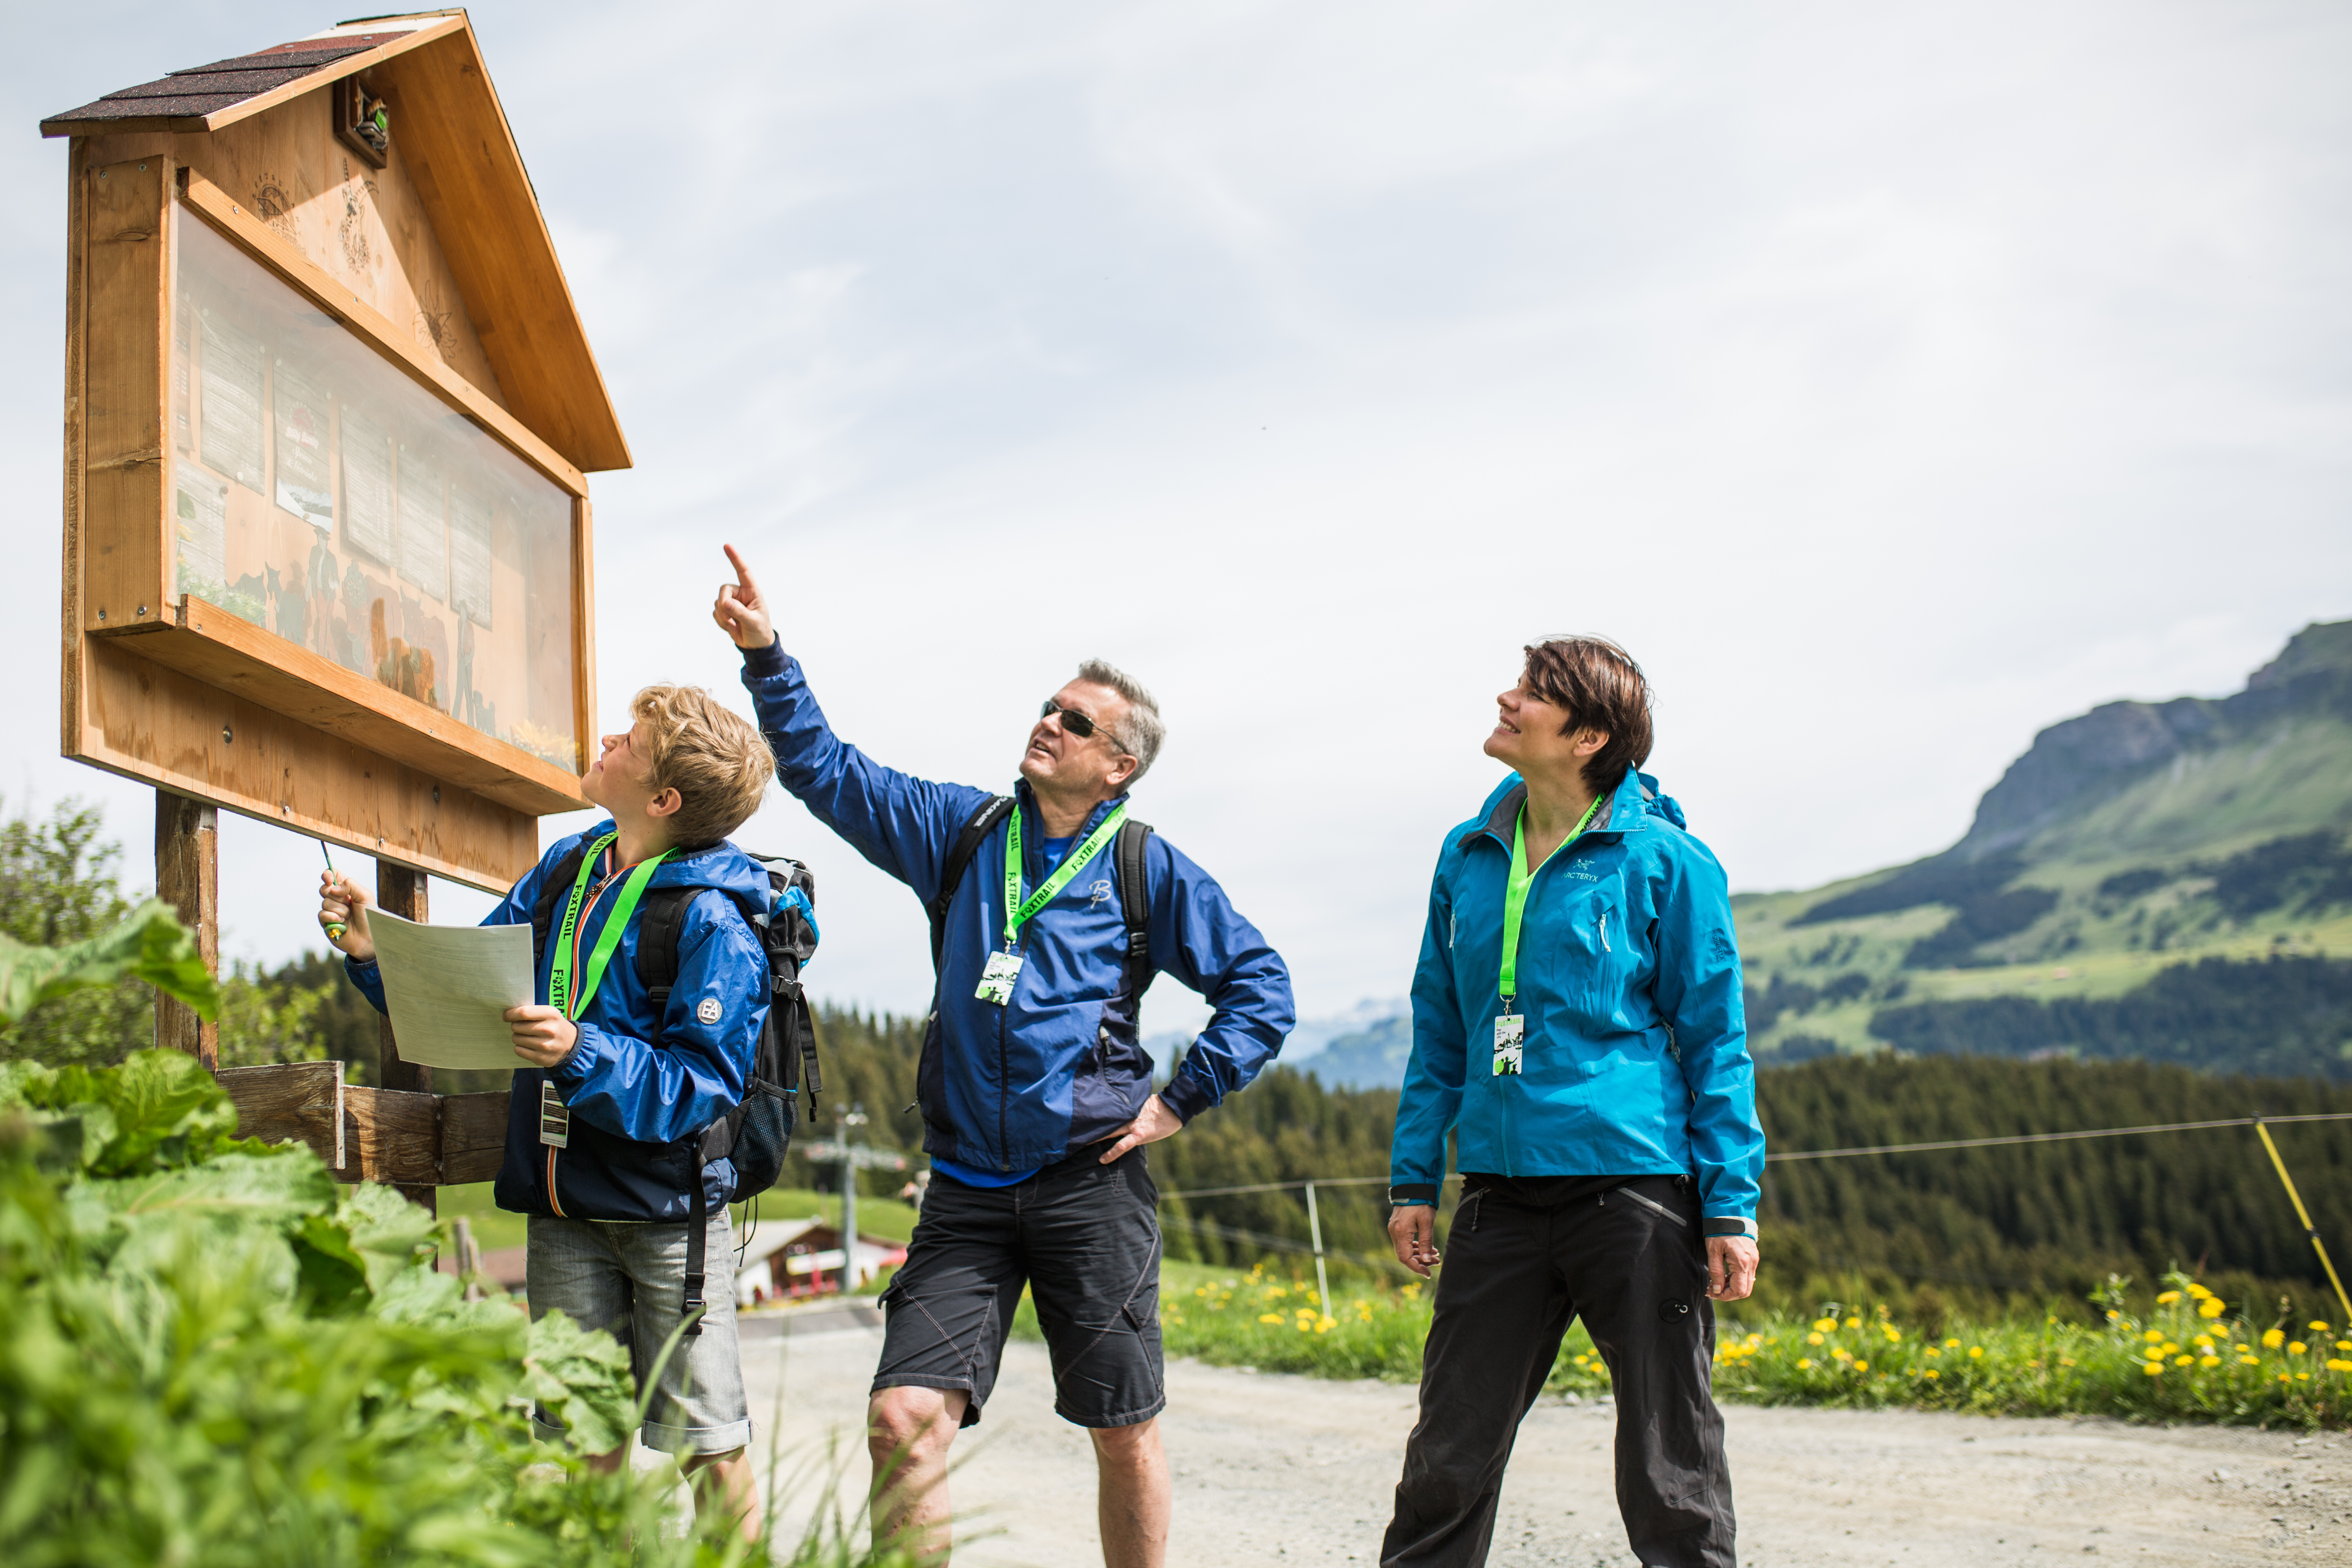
[875,1147,1167,1427]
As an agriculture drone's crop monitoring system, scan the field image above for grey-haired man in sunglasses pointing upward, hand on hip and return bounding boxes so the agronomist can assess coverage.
[710,546,1294,1568]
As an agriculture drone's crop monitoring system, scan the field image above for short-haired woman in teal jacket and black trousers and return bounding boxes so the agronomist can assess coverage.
[1381,637,1764,1568]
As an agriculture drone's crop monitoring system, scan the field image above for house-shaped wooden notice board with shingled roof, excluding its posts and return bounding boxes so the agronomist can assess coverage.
[42,12,628,891]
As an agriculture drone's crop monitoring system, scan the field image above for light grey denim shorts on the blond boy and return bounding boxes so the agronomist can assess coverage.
[527,1208,750,1453]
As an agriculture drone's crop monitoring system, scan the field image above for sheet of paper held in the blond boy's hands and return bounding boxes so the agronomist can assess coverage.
[367,910,536,1072]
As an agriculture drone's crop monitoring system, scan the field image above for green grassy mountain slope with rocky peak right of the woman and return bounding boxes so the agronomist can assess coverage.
[1733,623,2352,1074]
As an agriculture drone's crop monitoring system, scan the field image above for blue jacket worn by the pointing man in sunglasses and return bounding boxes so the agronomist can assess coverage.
[743,646,1294,1173]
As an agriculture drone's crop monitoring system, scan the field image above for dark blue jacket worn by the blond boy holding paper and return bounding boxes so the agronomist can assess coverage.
[346,818,769,1220]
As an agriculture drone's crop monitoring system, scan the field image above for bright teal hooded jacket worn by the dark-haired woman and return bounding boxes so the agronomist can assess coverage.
[1390,769,1764,1220]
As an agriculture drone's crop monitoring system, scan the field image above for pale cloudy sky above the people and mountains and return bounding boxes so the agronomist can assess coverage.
[0,0,2352,1027]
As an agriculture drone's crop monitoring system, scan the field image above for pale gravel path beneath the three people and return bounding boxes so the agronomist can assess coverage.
[743,1328,2352,1568]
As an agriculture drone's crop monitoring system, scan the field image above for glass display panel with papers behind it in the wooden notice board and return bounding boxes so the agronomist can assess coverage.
[169,205,579,771]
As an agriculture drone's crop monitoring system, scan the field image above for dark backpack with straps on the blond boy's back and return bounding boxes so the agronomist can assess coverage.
[532,849,826,1335]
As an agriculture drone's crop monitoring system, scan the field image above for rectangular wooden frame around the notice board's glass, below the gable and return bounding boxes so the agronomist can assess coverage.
[64,153,595,891]
